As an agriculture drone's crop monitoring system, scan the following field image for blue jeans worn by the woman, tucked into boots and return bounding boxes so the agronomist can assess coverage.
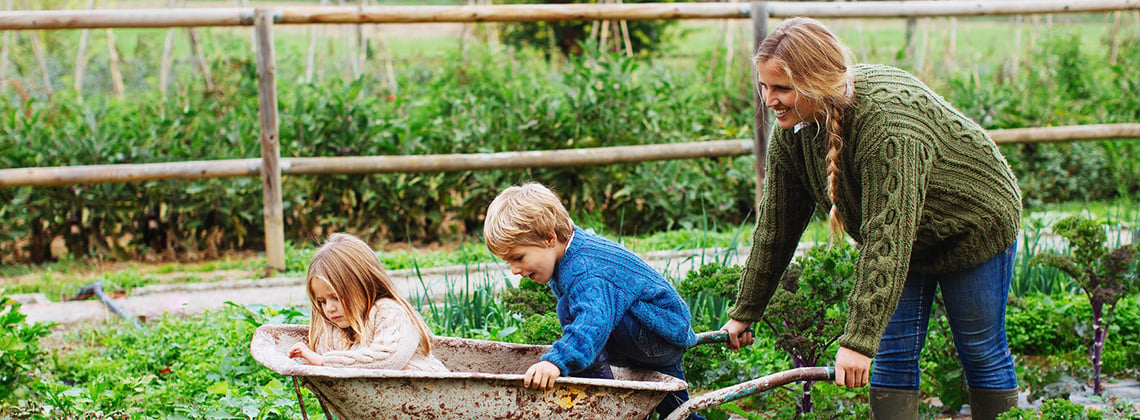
[871,242,1017,389]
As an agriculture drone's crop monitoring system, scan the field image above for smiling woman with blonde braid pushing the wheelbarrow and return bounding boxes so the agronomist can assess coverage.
[725,18,1021,419]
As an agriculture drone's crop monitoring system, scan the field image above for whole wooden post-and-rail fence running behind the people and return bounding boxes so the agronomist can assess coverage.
[0,0,1140,269]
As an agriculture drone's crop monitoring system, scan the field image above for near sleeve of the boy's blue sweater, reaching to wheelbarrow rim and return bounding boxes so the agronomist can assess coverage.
[542,274,633,375]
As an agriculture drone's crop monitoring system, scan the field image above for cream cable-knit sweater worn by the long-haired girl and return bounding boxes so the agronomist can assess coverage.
[315,298,448,372]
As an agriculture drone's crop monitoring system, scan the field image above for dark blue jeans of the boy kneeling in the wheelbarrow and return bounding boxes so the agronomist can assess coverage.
[559,310,705,420]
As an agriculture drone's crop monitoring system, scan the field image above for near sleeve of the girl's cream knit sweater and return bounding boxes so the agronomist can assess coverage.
[324,299,420,370]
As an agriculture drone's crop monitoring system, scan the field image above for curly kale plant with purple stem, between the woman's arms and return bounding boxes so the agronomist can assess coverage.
[762,243,857,413]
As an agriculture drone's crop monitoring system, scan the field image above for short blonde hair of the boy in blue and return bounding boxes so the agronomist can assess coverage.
[483,183,573,258]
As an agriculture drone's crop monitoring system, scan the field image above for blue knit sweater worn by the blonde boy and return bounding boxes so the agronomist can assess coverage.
[543,227,697,374]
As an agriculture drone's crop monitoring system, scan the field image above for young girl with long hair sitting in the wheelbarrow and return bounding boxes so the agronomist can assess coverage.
[288,233,447,372]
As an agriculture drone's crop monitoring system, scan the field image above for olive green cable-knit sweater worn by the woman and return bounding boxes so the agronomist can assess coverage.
[730,65,1021,356]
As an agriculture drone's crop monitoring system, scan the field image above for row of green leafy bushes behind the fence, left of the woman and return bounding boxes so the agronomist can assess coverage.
[0,48,755,263]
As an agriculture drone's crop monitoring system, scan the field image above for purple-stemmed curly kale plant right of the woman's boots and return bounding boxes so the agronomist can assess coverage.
[1034,216,1138,395]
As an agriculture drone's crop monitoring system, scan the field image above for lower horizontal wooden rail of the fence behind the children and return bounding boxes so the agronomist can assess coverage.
[0,123,1140,188]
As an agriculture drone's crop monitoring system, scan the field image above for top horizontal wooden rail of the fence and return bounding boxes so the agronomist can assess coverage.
[0,0,1140,30]
